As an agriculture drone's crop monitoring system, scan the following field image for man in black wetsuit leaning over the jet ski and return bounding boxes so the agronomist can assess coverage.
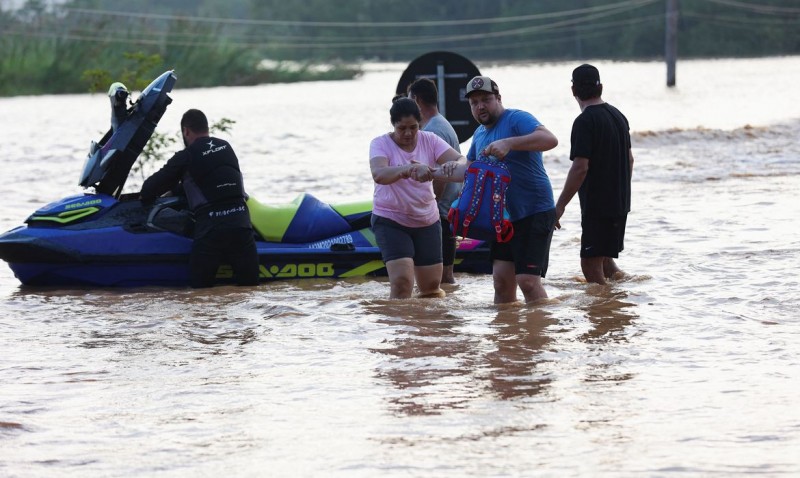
[141,109,258,287]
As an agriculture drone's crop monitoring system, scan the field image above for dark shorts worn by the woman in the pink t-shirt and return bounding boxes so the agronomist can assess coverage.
[372,214,442,266]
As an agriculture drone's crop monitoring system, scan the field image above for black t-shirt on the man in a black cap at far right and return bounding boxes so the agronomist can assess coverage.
[569,103,631,217]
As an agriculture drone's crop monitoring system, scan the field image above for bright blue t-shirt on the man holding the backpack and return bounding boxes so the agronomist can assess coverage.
[467,109,556,221]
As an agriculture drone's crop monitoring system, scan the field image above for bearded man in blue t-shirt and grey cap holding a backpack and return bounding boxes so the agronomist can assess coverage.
[465,76,558,304]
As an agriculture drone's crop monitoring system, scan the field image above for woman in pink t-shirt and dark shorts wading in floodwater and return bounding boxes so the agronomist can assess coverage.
[369,98,466,299]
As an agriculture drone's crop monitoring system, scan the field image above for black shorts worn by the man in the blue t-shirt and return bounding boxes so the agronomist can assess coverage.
[491,209,556,277]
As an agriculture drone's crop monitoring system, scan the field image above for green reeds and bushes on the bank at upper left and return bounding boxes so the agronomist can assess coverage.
[0,0,360,96]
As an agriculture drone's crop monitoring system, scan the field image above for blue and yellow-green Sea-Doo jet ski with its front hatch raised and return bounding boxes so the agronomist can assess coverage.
[0,71,491,287]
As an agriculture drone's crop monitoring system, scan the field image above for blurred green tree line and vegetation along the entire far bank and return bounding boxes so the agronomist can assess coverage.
[0,0,800,95]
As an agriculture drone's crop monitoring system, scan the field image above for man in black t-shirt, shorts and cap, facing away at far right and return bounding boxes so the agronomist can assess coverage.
[556,64,633,284]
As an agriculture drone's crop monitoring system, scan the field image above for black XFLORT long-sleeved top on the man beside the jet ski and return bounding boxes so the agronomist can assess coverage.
[141,137,251,237]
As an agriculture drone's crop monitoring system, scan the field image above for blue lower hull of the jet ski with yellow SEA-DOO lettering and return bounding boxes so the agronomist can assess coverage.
[0,227,491,287]
